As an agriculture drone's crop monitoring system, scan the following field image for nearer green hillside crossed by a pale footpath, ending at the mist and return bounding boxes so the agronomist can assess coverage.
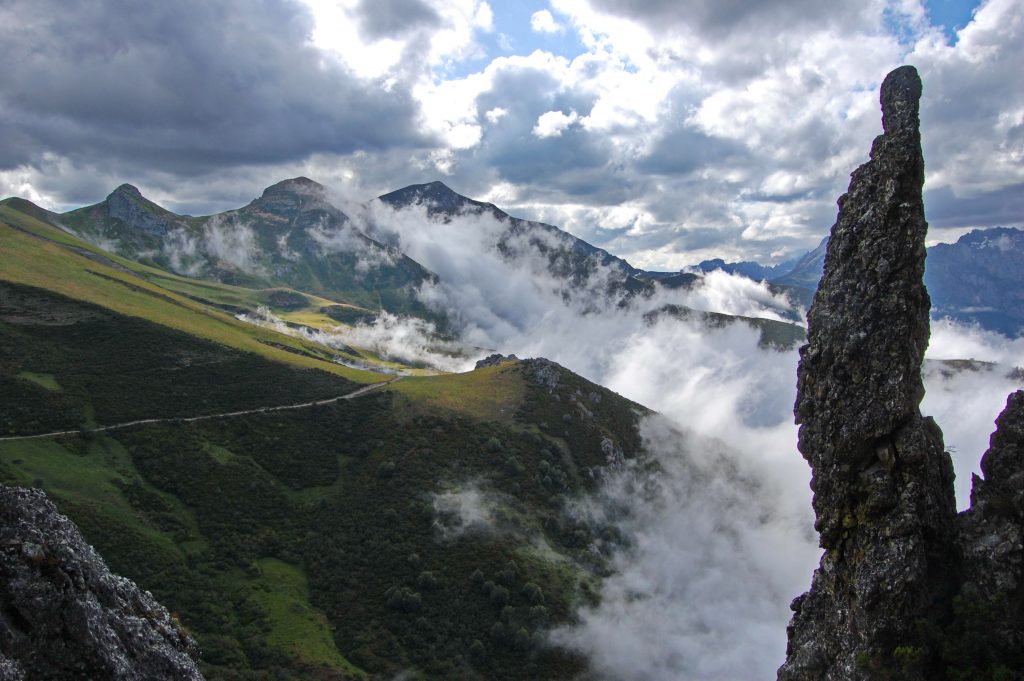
[0,268,643,679]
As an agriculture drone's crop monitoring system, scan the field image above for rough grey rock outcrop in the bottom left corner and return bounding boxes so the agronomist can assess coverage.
[0,486,203,681]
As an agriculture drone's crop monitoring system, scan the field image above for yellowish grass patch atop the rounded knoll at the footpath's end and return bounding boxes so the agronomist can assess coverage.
[389,361,525,423]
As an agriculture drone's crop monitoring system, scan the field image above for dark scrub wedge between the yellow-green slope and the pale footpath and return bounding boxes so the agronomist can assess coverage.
[0,282,366,434]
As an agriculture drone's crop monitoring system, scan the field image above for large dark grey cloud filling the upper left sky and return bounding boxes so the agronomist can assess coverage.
[0,0,430,175]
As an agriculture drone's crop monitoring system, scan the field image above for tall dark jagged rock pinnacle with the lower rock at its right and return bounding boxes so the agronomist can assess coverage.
[778,67,1024,681]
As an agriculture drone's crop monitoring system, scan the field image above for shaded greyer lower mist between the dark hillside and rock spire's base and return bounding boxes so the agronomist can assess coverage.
[552,417,819,681]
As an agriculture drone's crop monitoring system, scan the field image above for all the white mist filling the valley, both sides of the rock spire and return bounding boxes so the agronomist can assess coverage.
[333,199,1024,681]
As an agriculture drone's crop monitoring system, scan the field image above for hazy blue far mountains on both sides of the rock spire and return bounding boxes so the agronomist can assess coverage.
[697,227,1024,337]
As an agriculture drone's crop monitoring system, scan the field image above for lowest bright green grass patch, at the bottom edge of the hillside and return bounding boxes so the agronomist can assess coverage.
[252,558,366,677]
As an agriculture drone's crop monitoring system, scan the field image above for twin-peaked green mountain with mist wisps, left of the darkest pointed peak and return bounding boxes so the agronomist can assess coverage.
[56,177,436,318]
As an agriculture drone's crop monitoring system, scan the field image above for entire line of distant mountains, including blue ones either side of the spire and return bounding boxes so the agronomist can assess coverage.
[3,177,1024,336]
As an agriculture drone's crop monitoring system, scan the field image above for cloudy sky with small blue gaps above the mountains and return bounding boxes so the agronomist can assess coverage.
[0,0,1024,269]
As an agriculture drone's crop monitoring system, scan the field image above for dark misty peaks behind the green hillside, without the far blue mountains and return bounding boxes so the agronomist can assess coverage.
[2,177,810,329]
